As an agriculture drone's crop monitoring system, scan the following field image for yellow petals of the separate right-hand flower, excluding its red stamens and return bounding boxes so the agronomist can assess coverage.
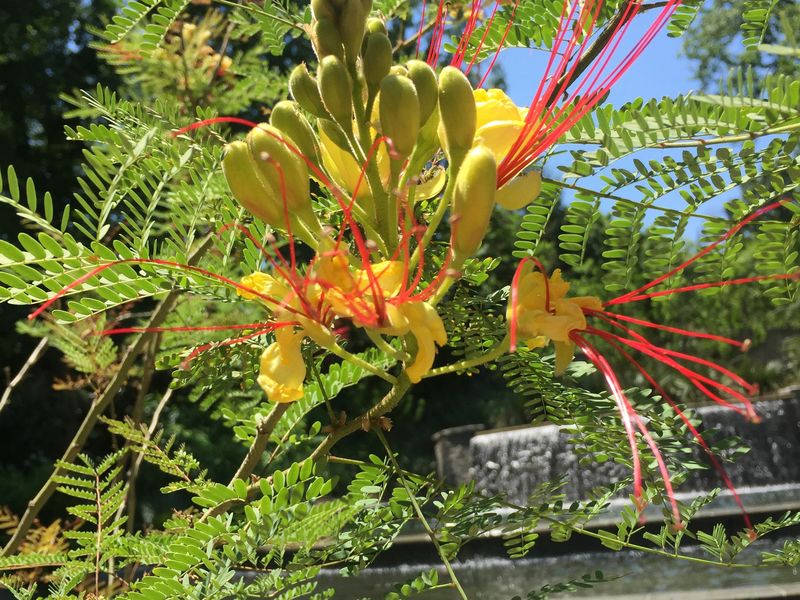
[507,263,602,375]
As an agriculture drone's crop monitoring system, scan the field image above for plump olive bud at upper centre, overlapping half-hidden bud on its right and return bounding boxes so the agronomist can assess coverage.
[380,75,419,158]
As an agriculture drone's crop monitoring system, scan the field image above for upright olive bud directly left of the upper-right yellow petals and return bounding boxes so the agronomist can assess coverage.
[439,67,477,163]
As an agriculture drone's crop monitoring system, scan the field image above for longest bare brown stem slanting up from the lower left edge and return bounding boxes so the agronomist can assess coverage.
[2,233,215,556]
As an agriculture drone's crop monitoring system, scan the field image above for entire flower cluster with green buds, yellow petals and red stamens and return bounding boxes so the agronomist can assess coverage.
[35,0,796,522]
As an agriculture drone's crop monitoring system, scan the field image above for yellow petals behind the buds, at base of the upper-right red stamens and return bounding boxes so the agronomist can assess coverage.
[473,89,542,210]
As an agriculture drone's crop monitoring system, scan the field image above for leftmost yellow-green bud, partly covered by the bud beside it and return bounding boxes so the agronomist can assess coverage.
[222,141,283,227]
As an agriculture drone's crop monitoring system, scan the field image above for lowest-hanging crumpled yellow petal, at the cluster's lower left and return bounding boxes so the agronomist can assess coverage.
[258,327,306,402]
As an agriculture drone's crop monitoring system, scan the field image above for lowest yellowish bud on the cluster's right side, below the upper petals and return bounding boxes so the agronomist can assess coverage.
[450,146,497,265]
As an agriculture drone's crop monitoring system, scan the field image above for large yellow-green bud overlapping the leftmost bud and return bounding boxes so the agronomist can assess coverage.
[247,123,313,224]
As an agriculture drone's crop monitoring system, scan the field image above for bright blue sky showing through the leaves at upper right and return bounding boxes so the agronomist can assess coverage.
[498,10,735,237]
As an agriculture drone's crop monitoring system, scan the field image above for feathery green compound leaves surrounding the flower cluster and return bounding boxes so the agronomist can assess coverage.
[0,0,800,600]
